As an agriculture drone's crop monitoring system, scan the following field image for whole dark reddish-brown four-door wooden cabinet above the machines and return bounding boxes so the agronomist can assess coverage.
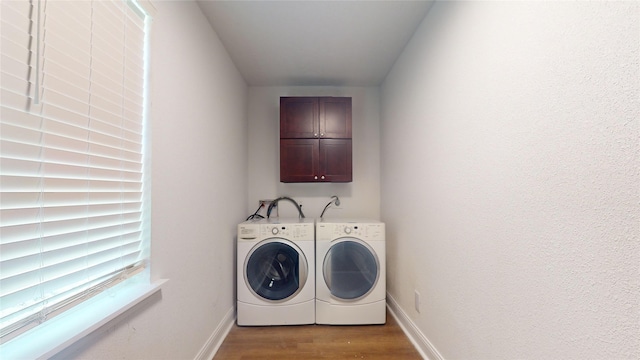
[280,97,352,182]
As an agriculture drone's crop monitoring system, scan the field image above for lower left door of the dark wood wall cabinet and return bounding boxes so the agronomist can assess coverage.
[280,139,319,182]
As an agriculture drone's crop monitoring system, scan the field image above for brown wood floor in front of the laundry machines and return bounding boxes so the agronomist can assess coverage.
[214,311,422,360]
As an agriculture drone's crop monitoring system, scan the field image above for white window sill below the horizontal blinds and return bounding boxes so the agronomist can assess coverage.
[0,278,168,360]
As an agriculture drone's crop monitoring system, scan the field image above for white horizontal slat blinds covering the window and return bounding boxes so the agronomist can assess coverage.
[0,0,146,336]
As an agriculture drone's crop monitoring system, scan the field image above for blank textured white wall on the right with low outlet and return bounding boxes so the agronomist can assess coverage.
[381,2,640,359]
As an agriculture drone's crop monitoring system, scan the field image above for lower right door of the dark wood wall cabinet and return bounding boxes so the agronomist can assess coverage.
[318,139,352,182]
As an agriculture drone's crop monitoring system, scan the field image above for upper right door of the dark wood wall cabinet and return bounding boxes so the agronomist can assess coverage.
[318,97,351,139]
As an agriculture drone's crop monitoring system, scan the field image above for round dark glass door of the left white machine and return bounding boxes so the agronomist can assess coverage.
[244,238,308,302]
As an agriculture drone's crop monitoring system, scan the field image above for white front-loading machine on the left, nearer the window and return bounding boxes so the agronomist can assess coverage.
[237,218,315,326]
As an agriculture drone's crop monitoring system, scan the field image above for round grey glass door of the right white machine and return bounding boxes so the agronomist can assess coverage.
[323,238,380,301]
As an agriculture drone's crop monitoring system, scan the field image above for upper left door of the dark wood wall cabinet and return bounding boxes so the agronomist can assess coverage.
[280,97,320,139]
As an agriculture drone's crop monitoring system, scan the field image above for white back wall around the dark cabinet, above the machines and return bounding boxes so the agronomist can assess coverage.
[247,86,380,219]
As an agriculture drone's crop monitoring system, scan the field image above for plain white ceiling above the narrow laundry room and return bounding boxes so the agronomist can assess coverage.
[198,0,432,86]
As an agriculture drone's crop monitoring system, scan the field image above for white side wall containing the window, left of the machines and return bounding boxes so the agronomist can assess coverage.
[52,1,248,360]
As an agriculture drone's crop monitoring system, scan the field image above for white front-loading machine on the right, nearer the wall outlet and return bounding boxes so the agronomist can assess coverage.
[316,219,387,325]
